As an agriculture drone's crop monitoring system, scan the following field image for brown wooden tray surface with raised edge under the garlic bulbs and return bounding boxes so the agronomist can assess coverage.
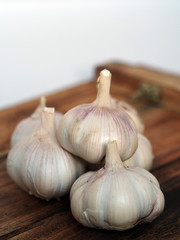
[0,63,180,240]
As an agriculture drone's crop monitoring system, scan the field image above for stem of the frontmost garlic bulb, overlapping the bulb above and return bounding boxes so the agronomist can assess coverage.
[105,141,124,168]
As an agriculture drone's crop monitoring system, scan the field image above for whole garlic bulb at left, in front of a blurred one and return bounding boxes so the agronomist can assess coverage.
[7,107,85,200]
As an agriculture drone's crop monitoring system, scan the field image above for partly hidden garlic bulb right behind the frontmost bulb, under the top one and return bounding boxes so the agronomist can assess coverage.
[124,134,154,170]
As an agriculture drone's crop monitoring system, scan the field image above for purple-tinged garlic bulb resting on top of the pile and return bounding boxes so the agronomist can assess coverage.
[58,70,137,163]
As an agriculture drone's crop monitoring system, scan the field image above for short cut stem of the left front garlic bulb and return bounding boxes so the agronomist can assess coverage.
[41,107,56,137]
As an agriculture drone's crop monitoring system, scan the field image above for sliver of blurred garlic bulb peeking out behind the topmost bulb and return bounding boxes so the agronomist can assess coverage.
[112,98,144,133]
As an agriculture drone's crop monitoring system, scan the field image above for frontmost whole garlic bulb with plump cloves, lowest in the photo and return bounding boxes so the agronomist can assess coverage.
[70,141,164,230]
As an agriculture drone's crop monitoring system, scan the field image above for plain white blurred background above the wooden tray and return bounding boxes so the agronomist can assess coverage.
[0,0,180,109]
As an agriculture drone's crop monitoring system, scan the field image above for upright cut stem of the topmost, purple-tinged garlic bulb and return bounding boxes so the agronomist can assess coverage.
[96,69,111,107]
